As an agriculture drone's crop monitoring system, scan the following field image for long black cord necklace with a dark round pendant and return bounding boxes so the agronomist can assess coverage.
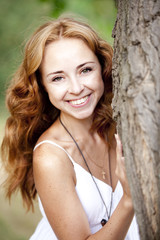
[59,116,113,226]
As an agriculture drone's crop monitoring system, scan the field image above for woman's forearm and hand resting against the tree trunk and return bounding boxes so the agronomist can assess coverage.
[88,135,134,240]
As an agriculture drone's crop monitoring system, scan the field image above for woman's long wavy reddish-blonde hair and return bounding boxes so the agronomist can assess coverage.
[1,18,115,210]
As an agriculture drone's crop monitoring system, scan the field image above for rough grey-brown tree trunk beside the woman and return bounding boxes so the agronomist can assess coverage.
[112,0,160,240]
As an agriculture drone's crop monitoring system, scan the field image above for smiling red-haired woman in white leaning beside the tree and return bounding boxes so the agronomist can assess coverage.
[2,15,139,240]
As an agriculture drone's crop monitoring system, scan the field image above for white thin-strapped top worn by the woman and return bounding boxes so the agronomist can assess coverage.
[30,140,140,240]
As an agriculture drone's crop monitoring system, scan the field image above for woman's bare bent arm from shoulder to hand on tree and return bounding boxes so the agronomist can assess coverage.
[34,137,134,240]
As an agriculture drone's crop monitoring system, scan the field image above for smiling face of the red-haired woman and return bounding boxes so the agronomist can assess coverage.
[41,38,104,119]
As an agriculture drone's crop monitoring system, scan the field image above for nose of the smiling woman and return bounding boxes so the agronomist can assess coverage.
[68,77,84,95]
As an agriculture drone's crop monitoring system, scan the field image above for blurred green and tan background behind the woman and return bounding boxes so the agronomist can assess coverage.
[0,0,116,240]
